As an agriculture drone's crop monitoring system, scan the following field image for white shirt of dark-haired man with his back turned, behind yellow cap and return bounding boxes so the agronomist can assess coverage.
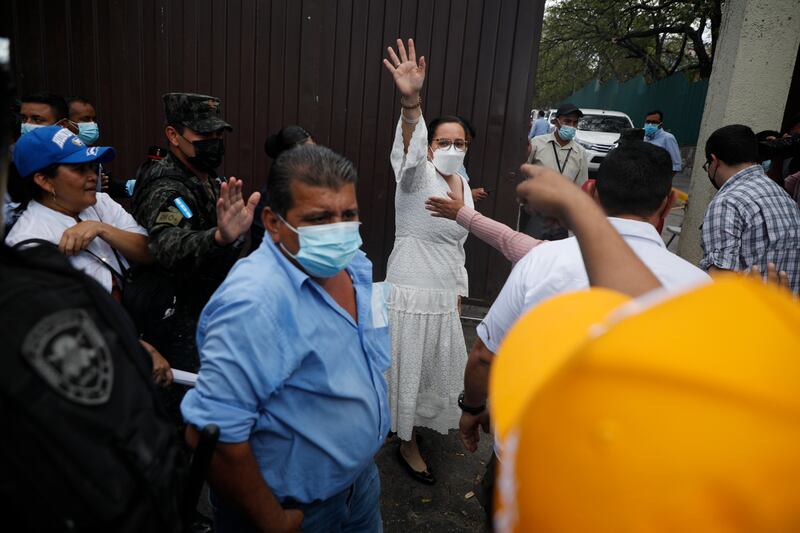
[478,217,711,353]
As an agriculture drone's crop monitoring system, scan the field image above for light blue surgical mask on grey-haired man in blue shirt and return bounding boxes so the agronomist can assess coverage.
[278,215,362,278]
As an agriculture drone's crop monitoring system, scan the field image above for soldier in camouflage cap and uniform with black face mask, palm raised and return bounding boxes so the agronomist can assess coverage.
[133,93,259,371]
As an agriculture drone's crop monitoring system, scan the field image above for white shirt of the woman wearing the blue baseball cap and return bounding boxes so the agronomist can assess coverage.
[6,192,147,292]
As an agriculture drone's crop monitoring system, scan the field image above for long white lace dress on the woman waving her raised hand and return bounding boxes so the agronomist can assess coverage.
[386,117,474,440]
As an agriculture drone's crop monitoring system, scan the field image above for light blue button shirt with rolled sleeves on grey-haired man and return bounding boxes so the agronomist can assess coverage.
[181,239,391,503]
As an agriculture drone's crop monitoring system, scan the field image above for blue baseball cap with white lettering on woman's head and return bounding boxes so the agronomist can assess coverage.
[14,126,117,177]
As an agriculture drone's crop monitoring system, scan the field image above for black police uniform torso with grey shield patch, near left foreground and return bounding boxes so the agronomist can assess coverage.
[0,245,183,532]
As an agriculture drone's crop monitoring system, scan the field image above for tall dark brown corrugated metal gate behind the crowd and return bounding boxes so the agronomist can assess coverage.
[0,0,544,300]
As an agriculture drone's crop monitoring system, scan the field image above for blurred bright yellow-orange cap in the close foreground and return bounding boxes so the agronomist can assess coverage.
[490,276,800,533]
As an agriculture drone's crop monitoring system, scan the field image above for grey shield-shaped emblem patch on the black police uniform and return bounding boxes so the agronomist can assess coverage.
[22,309,114,405]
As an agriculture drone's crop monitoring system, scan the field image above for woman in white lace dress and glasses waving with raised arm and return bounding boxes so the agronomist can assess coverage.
[384,39,473,483]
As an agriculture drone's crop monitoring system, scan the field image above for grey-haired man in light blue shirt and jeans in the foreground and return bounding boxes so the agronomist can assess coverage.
[181,145,391,533]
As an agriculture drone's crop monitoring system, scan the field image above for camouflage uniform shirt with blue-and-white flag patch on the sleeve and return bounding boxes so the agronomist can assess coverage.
[132,153,243,308]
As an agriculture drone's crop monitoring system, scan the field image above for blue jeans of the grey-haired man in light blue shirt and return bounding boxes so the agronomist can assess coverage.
[211,461,383,533]
